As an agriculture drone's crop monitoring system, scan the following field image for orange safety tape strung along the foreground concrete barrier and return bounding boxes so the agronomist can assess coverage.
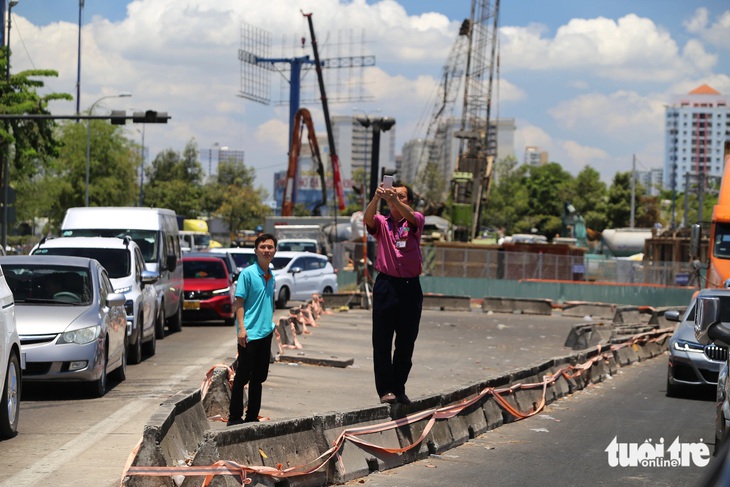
[122,328,672,487]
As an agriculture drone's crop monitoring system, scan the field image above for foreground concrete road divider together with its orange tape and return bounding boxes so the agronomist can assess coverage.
[123,314,672,487]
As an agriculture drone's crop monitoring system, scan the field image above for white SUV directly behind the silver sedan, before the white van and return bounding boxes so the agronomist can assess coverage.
[31,237,158,364]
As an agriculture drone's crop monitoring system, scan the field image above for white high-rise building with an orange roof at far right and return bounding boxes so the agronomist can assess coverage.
[664,84,730,191]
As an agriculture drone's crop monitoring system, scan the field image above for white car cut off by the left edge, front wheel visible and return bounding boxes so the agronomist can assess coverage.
[0,264,25,439]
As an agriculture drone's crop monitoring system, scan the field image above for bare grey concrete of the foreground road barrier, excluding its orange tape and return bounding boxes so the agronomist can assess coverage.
[123,329,671,487]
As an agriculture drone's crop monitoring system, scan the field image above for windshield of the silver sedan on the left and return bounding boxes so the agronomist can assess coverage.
[3,264,92,304]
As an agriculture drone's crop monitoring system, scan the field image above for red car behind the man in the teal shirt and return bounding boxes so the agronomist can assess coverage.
[182,256,235,325]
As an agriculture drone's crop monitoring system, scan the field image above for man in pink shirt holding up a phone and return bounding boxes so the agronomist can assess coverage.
[363,183,425,404]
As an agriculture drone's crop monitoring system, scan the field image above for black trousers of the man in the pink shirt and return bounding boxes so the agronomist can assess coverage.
[373,274,423,396]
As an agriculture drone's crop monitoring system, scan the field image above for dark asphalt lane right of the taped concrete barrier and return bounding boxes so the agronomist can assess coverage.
[347,357,714,487]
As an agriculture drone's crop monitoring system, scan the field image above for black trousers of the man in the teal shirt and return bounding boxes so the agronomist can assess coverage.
[228,331,274,421]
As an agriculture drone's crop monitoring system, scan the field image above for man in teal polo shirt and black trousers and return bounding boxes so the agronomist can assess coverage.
[227,233,276,426]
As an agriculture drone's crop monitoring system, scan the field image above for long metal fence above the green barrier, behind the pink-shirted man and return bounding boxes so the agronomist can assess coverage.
[333,242,696,286]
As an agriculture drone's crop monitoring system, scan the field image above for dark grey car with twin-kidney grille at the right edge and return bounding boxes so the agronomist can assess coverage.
[664,297,727,396]
